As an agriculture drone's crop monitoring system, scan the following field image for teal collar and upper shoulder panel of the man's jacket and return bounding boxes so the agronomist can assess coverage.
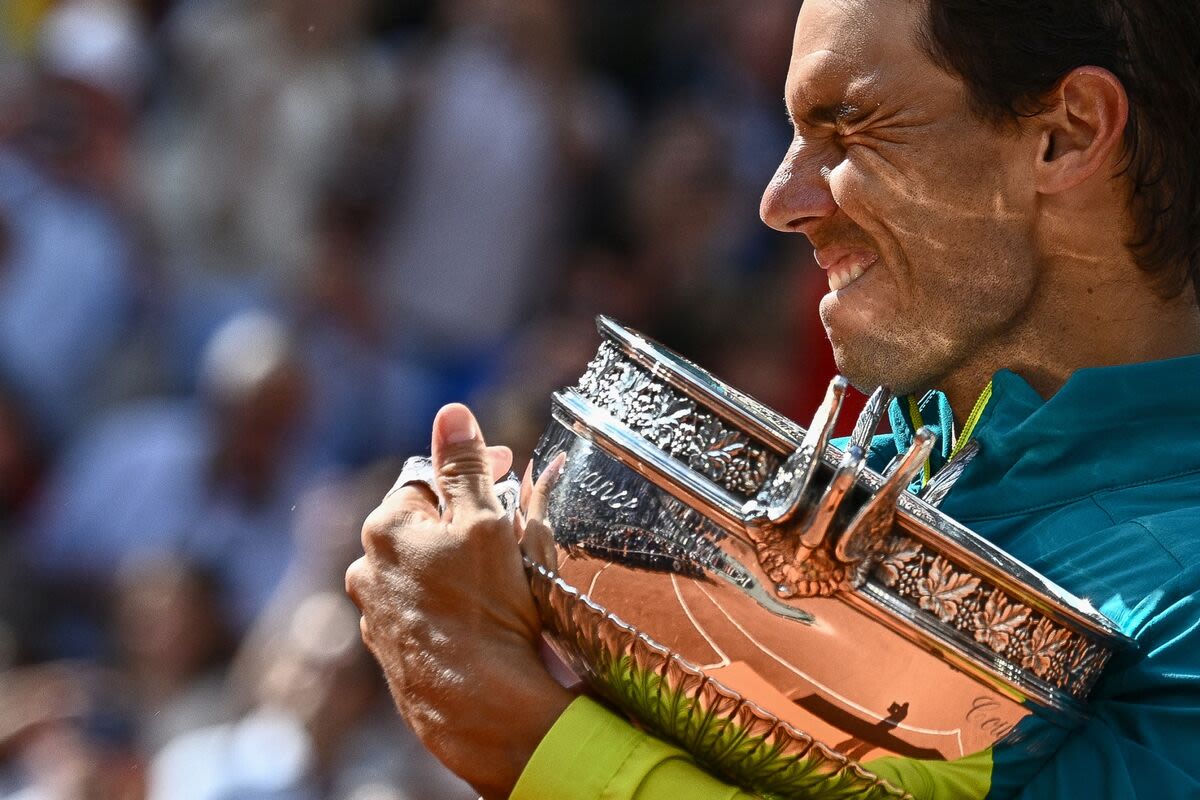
[889,355,1200,522]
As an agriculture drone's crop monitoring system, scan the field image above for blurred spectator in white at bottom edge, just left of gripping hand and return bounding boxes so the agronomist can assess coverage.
[149,593,475,800]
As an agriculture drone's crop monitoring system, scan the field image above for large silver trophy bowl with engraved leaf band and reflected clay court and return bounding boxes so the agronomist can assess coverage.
[527,318,1128,798]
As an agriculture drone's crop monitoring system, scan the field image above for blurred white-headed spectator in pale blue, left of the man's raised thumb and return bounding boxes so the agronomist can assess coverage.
[30,313,326,652]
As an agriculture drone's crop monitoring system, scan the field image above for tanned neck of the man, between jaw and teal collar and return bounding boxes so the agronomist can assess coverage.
[938,263,1200,425]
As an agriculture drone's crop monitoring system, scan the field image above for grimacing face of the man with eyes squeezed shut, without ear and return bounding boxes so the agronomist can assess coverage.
[762,0,1039,393]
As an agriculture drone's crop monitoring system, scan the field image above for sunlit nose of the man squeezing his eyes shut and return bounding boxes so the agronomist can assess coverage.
[758,137,838,233]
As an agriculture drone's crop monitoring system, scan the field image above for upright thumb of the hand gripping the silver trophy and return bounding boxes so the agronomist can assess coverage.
[432,403,504,518]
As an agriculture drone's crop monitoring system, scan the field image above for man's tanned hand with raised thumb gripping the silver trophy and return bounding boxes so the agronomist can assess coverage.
[346,404,572,798]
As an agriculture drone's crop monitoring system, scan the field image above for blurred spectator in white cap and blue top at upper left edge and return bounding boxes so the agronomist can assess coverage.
[0,0,144,437]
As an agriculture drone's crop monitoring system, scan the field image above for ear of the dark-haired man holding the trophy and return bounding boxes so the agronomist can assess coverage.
[1036,67,1129,194]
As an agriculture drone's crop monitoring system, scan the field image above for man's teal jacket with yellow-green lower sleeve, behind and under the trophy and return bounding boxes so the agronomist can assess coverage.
[512,356,1200,800]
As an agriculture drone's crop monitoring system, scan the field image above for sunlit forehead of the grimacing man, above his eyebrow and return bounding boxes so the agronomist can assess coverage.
[788,0,935,91]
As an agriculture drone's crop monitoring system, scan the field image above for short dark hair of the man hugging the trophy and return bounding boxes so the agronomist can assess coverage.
[923,0,1200,304]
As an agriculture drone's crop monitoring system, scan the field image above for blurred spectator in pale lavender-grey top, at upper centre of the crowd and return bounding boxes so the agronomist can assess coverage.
[380,0,619,391]
